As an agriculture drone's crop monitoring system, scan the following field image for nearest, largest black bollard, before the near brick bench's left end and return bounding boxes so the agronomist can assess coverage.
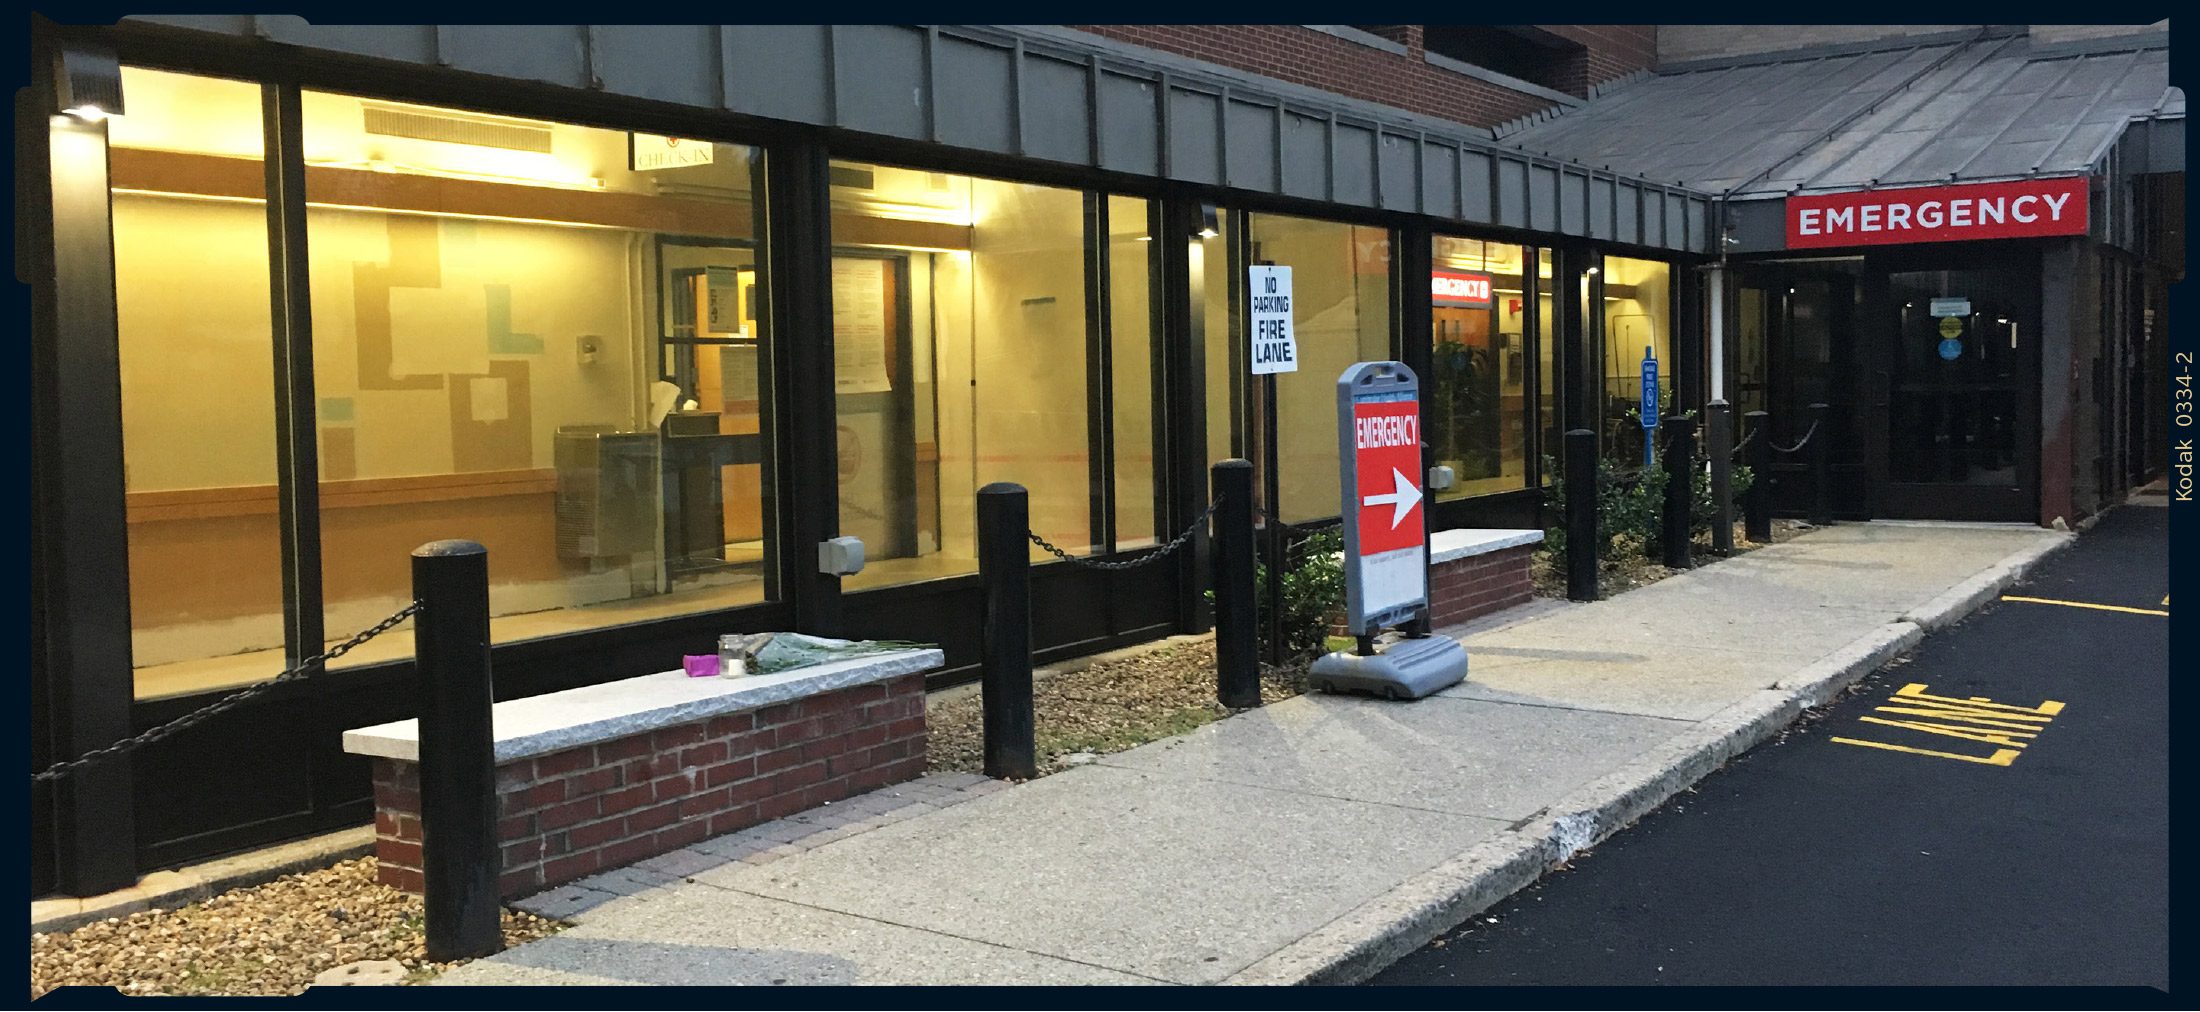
[414,541,504,961]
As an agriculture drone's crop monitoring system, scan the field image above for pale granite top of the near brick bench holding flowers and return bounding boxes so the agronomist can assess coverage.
[343,649,946,763]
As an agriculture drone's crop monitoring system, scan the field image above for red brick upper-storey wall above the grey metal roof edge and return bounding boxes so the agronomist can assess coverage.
[1071,24,1657,125]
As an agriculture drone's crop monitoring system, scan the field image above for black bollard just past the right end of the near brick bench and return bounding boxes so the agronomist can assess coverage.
[977,482,1038,781]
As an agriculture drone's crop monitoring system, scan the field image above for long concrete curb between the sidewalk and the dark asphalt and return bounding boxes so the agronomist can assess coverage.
[1225,537,2075,983]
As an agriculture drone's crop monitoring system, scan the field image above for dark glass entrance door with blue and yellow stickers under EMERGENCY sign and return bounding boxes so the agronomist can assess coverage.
[1872,260,2039,521]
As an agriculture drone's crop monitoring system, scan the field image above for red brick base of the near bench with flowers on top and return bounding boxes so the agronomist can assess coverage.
[374,675,924,898]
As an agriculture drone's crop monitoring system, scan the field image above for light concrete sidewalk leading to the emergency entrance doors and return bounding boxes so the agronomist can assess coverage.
[440,524,2070,983]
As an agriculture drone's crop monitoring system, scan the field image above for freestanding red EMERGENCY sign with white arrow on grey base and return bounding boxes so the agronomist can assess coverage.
[1309,361,1467,700]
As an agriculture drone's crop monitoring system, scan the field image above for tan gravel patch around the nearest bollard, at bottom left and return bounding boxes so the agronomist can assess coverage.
[31,858,563,999]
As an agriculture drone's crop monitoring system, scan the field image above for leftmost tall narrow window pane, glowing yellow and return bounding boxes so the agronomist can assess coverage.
[108,66,284,697]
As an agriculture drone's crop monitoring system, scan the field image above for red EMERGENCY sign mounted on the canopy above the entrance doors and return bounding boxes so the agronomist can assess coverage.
[1786,176,2088,249]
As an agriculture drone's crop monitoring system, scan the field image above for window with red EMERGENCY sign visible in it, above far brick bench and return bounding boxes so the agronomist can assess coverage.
[1421,235,1527,502]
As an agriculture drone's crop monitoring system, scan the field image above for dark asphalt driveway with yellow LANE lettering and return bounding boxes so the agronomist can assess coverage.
[1368,506,2169,990]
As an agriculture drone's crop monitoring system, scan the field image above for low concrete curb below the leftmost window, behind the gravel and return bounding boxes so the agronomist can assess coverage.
[31,825,374,933]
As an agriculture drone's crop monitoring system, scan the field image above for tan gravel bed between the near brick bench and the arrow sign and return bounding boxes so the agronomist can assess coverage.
[926,638,1307,777]
